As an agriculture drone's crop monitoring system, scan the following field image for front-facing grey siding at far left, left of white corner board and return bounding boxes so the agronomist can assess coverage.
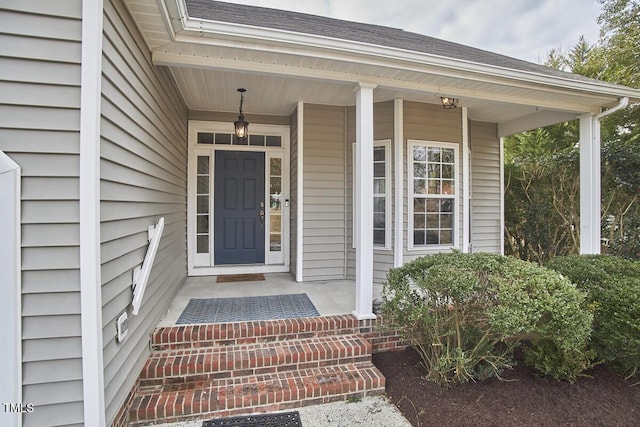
[0,0,84,427]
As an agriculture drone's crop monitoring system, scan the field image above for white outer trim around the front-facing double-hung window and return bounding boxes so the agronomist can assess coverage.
[407,139,461,252]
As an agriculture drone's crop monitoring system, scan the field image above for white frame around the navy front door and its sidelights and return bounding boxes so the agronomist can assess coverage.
[187,120,290,276]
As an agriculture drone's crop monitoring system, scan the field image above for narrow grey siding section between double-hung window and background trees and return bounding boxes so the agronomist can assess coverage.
[469,121,503,254]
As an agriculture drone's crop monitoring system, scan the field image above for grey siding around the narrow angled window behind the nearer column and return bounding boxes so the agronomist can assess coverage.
[347,101,395,283]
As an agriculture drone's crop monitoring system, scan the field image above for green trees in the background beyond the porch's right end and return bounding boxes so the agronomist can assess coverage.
[505,0,640,262]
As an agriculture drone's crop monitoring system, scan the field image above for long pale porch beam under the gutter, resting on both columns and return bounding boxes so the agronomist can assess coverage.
[152,51,611,113]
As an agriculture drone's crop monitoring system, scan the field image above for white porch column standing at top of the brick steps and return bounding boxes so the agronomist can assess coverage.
[353,83,376,319]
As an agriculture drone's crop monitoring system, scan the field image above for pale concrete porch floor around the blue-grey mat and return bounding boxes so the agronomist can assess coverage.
[158,273,382,327]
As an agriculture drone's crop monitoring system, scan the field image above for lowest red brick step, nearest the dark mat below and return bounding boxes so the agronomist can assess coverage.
[130,363,385,422]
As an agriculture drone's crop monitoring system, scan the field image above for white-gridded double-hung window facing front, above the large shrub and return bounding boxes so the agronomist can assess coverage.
[408,141,458,249]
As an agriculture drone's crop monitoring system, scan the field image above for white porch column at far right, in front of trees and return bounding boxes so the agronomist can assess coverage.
[580,114,600,254]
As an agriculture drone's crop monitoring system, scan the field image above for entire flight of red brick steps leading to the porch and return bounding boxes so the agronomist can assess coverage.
[128,315,385,427]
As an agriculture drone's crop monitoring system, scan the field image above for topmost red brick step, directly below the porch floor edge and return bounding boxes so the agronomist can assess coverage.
[151,315,362,351]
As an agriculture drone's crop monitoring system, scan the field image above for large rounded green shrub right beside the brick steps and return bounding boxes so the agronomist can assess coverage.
[383,253,592,385]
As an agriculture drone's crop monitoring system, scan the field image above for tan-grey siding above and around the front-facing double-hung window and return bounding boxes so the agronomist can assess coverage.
[402,101,463,263]
